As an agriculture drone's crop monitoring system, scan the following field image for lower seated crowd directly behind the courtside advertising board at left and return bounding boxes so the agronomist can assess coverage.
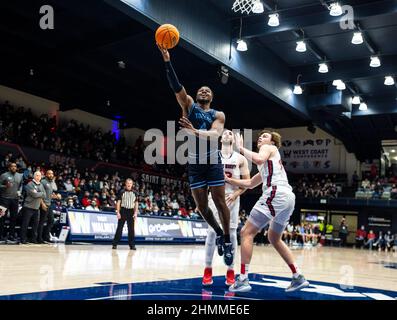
[0,154,199,219]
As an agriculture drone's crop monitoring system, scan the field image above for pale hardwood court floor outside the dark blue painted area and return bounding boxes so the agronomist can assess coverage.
[0,245,397,295]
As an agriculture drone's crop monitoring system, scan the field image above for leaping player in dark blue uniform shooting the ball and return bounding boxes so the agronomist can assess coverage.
[159,48,234,266]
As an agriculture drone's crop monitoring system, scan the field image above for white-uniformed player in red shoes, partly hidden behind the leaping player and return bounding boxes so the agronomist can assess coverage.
[202,130,250,286]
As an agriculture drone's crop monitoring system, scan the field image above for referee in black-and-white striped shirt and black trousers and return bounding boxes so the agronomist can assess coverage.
[113,179,138,250]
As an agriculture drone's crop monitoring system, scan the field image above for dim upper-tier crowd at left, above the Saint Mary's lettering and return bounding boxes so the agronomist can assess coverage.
[0,101,185,177]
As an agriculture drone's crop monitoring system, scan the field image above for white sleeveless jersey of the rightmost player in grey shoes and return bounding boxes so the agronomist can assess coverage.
[258,151,292,193]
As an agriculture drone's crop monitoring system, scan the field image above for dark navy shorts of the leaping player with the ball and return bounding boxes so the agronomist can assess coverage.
[188,163,225,190]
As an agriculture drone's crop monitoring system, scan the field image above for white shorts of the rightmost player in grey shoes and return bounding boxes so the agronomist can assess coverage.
[248,186,295,234]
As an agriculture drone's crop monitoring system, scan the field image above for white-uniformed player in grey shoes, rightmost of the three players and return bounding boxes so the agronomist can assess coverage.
[226,130,309,292]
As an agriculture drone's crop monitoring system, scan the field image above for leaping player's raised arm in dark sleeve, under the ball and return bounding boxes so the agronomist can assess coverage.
[159,47,193,117]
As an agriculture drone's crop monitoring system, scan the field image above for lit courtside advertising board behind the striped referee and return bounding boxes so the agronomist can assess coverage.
[67,210,208,242]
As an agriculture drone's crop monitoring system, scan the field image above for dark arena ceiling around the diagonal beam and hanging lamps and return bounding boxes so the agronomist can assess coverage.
[0,0,397,160]
